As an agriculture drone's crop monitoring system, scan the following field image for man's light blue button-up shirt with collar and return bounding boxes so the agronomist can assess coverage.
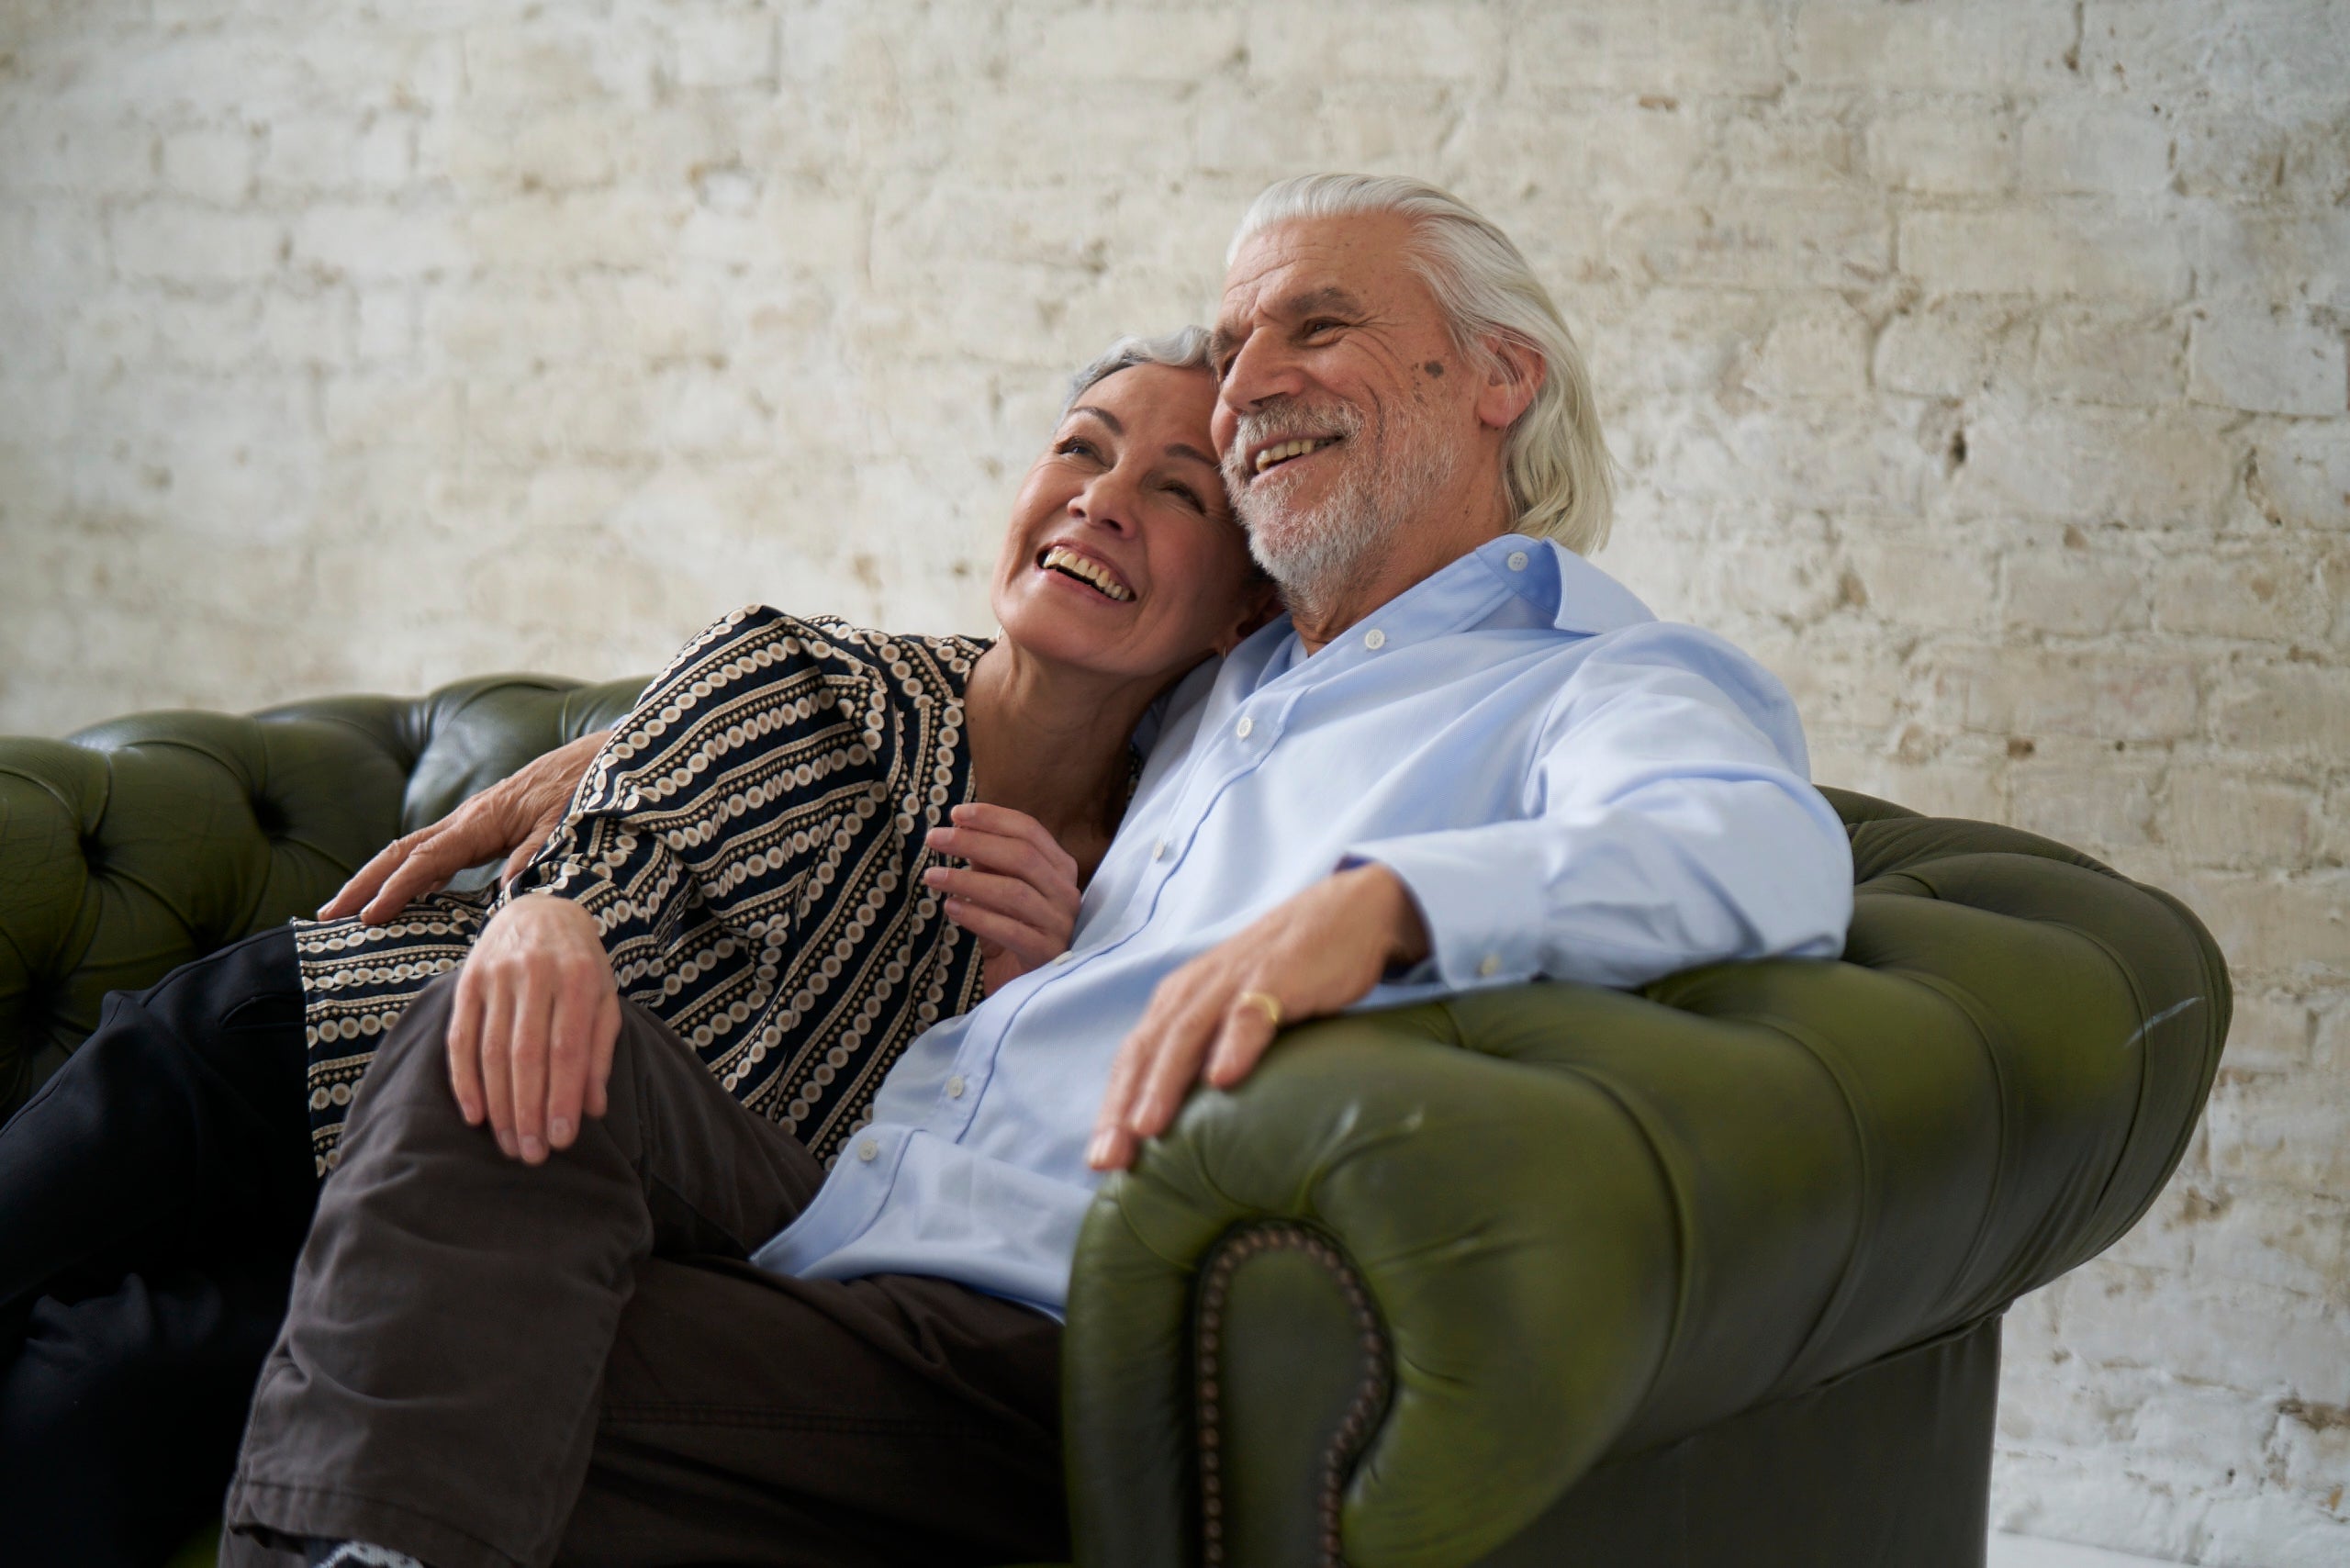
[755,533,1852,1314]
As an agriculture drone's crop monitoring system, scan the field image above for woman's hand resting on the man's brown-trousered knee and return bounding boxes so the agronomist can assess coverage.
[449,893,621,1166]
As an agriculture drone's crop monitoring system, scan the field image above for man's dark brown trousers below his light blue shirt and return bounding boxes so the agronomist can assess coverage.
[221,976,1067,1568]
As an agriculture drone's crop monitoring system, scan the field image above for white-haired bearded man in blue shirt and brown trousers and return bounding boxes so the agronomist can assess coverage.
[226,176,1852,1568]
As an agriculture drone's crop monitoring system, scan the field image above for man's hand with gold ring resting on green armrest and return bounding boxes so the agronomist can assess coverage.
[1086,865,1428,1170]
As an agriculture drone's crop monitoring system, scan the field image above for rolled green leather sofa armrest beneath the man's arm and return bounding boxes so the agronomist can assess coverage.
[1065,851,2228,1568]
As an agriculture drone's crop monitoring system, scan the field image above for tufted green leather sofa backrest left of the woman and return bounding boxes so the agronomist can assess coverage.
[0,675,643,1116]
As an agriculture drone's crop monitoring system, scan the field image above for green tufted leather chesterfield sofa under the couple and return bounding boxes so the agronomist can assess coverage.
[0,677,2230,1568]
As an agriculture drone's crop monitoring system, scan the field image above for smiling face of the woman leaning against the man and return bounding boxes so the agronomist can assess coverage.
[991,364,1271,679]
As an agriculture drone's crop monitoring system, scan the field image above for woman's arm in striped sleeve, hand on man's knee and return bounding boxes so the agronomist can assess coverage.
[449,607,889,1164]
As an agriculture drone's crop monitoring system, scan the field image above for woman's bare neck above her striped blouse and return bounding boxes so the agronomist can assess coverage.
[964,637,1166,881]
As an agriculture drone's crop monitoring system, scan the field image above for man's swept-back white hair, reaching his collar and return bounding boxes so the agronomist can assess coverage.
[1225,174,1615,554]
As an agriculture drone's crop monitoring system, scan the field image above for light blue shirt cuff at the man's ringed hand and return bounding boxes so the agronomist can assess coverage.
[1339,832,1544,990]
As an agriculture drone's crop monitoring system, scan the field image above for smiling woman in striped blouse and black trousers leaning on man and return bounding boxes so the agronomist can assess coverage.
[0,330,1271,1563]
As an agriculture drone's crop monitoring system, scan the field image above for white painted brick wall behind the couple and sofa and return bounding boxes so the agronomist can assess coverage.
[0,0,2350,1568]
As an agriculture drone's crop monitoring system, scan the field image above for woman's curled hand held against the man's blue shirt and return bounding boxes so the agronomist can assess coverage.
[922,804,1081,994]
